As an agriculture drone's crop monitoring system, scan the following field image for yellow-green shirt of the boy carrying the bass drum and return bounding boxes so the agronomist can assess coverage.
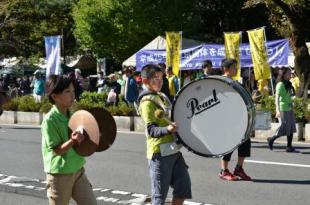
[139,96,174,159]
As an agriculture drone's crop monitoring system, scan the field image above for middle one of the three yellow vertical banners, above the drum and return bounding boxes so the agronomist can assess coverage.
[224,32,241,80]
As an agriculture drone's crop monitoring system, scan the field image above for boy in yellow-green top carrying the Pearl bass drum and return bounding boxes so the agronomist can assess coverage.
[138,64,192,205]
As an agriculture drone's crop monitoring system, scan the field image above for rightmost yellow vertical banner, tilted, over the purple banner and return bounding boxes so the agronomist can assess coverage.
[248,28,270,80]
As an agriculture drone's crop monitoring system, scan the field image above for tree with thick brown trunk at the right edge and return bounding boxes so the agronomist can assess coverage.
[245,0,310,98]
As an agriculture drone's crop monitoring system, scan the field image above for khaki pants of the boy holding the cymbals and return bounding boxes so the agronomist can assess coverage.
[46,168,97,205]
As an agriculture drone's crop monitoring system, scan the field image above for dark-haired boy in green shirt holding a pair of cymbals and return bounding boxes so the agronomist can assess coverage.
[41,75,97,205]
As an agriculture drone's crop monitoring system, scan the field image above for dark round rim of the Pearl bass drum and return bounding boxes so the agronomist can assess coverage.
[171,76,255,157]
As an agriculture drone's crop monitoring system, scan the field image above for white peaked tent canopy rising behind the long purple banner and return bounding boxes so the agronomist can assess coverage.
[122,36,203,66]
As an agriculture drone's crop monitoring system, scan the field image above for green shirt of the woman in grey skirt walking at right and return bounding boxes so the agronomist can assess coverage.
[276,82,292,112]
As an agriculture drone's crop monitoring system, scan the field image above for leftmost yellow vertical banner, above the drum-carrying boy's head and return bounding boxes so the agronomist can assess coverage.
[166,32,182,76]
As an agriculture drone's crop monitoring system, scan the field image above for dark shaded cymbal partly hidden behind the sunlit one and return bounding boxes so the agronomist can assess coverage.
[89,108,116,152]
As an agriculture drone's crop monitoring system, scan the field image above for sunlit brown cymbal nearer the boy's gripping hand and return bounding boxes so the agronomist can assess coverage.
[69,110,99,156]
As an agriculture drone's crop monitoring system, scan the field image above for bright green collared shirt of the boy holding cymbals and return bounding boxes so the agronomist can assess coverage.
[41,105,85,174]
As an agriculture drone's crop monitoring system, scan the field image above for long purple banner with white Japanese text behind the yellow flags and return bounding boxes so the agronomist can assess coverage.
[136,39,290,71]
